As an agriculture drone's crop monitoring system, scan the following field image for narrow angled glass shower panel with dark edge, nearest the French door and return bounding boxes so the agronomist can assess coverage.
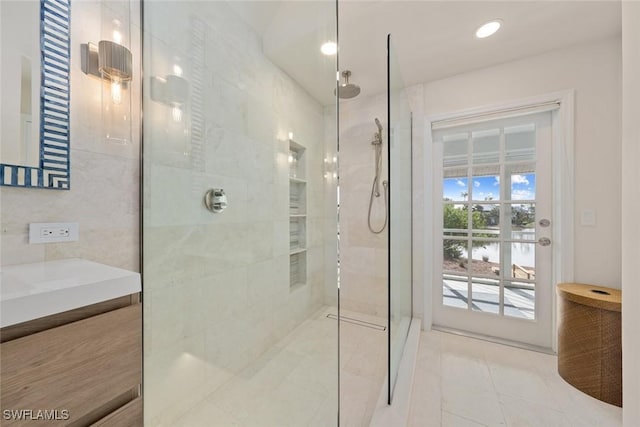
[387,35,412,403]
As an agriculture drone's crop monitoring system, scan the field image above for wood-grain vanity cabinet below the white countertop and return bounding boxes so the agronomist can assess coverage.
[0,295,142,427]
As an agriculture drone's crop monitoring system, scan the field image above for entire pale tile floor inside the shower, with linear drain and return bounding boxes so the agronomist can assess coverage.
[171,307,387,427]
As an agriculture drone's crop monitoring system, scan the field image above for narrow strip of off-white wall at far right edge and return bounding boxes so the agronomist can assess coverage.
[622,1,640,427]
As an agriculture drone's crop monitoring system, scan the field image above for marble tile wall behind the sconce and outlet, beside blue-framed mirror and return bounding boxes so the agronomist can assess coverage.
[0,1,140,271]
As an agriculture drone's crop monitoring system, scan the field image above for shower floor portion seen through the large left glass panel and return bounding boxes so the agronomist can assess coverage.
[172,309,338,427]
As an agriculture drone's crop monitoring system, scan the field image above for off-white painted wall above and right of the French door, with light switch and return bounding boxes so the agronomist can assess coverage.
[424,37,621,294]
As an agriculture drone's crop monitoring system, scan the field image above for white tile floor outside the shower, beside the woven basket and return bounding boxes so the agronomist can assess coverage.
[408,331,622,427]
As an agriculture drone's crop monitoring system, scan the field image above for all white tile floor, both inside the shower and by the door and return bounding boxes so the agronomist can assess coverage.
[166,307,622,427]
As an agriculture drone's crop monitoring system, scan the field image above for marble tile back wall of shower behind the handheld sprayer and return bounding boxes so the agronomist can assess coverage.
[326,95,388,317]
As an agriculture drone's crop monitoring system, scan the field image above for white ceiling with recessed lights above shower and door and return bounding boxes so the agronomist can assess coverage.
[230,0,621,105]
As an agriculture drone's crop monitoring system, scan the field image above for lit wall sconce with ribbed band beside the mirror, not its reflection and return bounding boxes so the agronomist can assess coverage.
[81,19,133,144]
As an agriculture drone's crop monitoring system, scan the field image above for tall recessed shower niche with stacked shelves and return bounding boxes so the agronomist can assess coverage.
[289,139,307,289]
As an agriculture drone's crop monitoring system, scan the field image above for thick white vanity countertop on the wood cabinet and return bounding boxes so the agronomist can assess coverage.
[0,258,142,327]
